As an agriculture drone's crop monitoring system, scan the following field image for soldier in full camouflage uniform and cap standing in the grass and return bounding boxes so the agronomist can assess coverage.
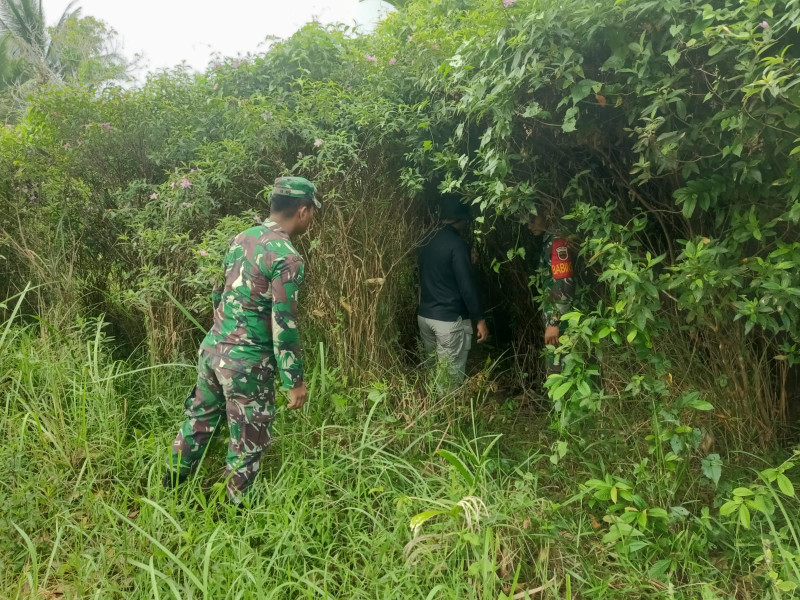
[163,177,322,503]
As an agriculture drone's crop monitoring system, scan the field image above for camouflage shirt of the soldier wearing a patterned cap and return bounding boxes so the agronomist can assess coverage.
[201,220,303,388]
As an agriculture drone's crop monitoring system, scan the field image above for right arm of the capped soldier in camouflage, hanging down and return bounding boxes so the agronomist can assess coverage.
[271,254,305,390]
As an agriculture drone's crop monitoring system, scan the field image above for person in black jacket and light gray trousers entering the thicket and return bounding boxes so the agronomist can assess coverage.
[417,195,489,386]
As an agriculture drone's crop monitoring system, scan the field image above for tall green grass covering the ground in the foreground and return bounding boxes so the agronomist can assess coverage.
[0,301,798,599]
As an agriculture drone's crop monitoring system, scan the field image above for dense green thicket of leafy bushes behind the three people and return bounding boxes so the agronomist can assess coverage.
[0,0,800,446]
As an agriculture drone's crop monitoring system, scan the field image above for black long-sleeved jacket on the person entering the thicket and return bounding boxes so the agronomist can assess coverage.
[419,225,483,322]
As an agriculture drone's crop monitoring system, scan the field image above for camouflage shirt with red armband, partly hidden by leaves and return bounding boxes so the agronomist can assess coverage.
[537,232,575,327]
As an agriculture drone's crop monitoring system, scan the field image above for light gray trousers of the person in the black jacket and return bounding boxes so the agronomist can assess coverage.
[417,316,472,385]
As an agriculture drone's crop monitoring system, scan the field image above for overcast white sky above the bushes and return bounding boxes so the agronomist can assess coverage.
[43,0,390,75]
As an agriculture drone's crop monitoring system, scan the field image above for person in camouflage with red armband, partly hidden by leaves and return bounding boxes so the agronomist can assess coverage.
[528,213,575,376]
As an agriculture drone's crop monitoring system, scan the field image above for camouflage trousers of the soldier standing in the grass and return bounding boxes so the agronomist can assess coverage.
[170,350,275,502]
